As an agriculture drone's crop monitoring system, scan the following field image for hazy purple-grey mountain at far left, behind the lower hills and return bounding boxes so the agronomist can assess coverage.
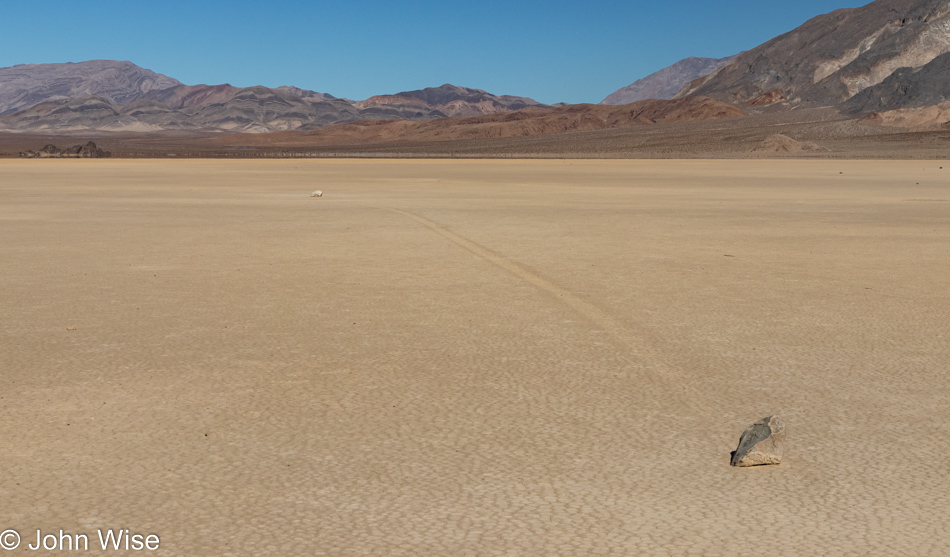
[0,60,181,114]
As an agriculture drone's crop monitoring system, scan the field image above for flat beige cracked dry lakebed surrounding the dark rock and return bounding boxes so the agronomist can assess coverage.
[0,160,950,557]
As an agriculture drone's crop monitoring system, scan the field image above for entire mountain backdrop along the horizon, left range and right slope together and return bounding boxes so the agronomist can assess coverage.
[0,0,950,135]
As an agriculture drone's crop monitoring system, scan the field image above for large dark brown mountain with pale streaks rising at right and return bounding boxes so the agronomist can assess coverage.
[676,0,950,108]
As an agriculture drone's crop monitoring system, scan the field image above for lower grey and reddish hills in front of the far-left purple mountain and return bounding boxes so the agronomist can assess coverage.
[0,85,545,133]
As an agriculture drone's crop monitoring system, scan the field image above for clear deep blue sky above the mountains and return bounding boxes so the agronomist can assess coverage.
[0,0,867,103]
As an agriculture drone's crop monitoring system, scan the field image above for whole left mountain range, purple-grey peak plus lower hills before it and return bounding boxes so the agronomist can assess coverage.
[0,60,547,133]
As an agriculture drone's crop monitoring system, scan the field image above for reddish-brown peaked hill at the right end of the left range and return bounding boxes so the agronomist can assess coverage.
[354,84,548,120]
